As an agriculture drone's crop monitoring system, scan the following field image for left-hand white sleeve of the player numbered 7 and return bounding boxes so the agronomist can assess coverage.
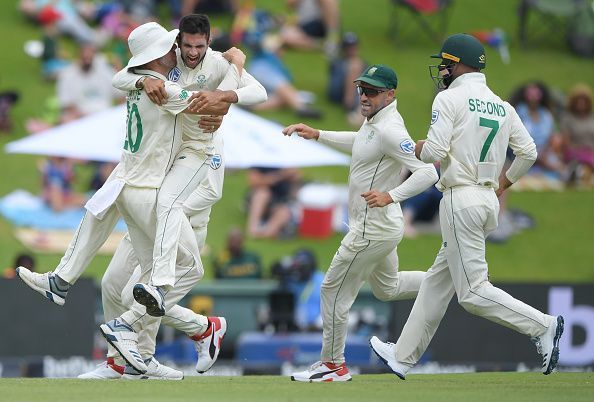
[421,92,455,162]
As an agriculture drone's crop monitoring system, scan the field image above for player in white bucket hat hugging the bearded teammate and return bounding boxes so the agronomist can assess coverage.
[17,22,227,379]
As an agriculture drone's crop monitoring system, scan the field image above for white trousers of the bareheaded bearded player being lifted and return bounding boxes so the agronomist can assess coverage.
[149,149,209,289]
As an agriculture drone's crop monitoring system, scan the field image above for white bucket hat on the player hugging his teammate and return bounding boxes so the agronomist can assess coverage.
[126,22,179,68]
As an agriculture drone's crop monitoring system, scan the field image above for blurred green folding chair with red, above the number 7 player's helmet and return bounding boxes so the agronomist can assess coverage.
[388,0,453,42]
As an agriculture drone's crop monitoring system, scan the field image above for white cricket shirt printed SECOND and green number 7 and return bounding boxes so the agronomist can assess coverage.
[421,72,536,191]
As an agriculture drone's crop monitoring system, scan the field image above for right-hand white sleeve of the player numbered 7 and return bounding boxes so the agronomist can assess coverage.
[505,105,537,183]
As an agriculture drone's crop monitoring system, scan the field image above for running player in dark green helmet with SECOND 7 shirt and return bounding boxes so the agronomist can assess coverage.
[370,34,563,379]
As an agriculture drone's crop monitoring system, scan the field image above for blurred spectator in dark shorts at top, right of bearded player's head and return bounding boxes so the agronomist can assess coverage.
[282,0,340,58]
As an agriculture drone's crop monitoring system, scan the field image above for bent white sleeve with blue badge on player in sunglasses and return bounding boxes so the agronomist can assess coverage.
[380,130,439,202]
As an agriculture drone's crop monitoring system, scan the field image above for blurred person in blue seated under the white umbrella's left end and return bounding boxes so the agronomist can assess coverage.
[42,157,86,211]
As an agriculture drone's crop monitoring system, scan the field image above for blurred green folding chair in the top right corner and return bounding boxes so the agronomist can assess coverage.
[518,0,587,47]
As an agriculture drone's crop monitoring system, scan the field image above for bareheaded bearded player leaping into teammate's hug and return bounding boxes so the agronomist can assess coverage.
[114,14,267,316]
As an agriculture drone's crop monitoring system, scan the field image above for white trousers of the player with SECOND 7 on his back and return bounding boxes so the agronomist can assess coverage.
[396,186,554,367]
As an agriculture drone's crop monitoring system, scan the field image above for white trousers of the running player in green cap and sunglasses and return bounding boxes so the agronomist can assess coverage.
[321,229,425,364]
